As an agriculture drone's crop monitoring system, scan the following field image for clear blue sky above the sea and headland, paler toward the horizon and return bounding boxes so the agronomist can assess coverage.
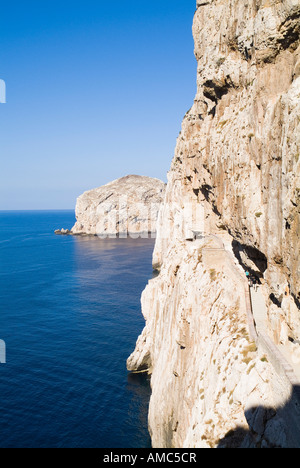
[0,0,196,210]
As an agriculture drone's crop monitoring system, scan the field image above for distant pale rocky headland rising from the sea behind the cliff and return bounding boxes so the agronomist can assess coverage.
[71,175,165,237]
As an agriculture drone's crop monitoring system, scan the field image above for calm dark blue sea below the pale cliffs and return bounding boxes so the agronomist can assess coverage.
[0,212,153,448]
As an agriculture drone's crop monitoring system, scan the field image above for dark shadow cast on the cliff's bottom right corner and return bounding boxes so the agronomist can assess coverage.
[217,385,300,448]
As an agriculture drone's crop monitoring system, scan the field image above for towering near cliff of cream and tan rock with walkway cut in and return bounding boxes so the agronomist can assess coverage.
[127,0,300,447]
